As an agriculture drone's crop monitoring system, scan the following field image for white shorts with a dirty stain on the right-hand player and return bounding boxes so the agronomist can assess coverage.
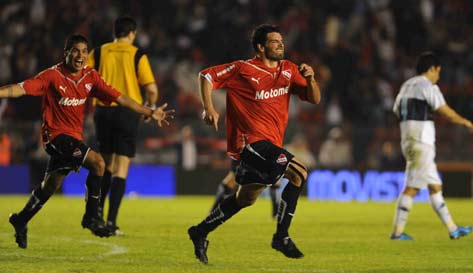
[401,141,442,189]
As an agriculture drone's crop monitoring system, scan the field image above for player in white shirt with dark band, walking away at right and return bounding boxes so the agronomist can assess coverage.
[391,52,473,240]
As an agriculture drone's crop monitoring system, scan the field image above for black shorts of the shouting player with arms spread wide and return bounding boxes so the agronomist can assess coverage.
[45,134,90,175]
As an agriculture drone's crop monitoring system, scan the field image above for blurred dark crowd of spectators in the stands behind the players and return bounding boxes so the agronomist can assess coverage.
[0,0,473,169]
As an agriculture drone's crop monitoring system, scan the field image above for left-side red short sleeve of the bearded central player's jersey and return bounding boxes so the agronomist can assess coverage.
[199,61,241,90]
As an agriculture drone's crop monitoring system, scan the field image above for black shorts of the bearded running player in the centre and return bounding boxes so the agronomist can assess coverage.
[235,140,294,185]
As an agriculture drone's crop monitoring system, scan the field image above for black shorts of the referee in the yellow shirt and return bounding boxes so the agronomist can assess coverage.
[94,106,140,157]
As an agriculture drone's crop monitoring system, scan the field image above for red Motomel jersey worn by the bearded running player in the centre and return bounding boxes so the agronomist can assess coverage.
[200,57,307,158]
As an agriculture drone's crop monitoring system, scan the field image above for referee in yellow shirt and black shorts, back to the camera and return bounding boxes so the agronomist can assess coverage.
[87,16,158,236]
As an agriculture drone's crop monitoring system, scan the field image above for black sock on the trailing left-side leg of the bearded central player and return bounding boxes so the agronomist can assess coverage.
[197,194,242,236]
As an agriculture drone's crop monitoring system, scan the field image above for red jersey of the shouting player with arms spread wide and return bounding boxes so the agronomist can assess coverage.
[19,63,121,140]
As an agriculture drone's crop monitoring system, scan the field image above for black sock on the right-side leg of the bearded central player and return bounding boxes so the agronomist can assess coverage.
[276,182,302,237]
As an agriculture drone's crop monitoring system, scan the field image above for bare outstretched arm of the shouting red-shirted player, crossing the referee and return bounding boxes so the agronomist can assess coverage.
[117,94,174,127]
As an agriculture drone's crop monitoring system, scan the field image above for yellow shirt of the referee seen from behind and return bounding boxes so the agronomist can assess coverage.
[87,42,155,106]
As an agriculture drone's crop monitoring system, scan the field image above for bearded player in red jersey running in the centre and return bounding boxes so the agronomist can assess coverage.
[188,24,320,264]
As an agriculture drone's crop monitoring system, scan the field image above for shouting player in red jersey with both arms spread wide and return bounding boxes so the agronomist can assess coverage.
[0,35,174,248]
